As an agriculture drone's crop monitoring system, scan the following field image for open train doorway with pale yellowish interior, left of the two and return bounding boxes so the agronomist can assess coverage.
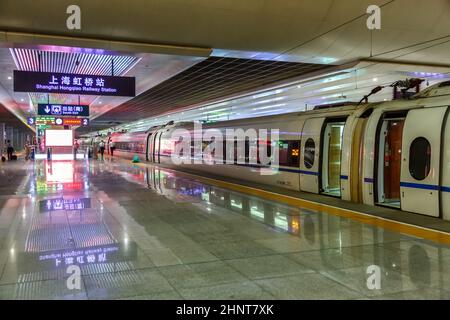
[322,122,345,197]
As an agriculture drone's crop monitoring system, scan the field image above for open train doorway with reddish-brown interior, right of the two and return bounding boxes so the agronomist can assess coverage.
[377,118,405,208]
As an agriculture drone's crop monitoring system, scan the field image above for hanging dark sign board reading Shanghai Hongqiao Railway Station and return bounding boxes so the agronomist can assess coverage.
[14,70,136,97]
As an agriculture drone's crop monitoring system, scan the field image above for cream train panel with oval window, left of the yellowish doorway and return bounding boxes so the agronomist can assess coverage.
[300,118,325,193]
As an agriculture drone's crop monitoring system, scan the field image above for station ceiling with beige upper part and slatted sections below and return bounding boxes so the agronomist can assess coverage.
[0,0,450,132]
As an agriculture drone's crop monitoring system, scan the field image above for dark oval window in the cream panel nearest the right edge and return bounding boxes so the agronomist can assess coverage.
[409,137,431,180]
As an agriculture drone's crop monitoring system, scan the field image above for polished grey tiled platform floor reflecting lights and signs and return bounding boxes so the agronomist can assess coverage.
[0,159,450,299]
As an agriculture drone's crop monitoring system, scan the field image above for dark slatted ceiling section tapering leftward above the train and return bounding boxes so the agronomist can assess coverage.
[86,57,327,130]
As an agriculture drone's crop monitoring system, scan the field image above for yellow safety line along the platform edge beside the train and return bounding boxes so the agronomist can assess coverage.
[122,159,450,245]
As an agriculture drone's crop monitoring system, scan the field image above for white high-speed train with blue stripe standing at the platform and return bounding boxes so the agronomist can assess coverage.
[80,81,450,220]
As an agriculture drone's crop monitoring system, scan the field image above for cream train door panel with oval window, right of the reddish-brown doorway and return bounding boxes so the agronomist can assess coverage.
[400,107,447,217]
